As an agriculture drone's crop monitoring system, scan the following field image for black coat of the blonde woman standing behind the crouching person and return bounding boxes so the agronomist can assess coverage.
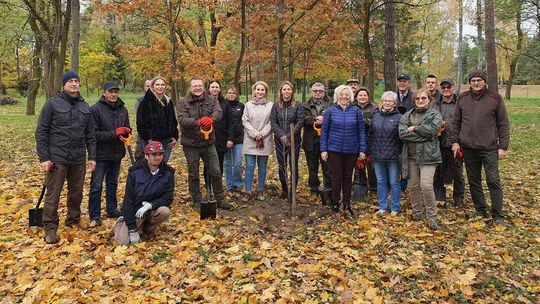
[137,90,178,141]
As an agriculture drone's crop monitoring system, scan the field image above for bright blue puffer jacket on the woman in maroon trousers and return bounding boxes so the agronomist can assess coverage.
[321,104,367,154]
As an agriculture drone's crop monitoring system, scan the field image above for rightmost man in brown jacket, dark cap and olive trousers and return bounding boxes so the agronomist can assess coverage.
[452,70,510,225]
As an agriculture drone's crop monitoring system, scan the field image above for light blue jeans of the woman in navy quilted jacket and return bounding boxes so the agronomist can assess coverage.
[374,161,401,212]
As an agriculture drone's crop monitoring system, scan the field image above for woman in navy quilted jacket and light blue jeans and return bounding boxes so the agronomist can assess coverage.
[368,91,401,215]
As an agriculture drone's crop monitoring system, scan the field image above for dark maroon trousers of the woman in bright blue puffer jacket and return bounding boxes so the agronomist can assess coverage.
[328,152,358,208]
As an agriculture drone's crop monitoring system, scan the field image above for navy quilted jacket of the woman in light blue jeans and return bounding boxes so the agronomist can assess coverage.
[368,107,401,162]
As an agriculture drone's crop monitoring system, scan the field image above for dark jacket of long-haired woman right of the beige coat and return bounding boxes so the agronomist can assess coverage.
[270,102,304,145]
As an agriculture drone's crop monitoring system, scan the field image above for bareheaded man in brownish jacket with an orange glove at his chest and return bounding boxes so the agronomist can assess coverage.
[178,77,231,210]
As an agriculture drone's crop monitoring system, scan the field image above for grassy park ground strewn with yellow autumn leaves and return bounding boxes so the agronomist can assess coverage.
[0,99,540,303]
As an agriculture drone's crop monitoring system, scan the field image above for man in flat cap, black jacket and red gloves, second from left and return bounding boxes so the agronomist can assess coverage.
[88,81,131,227]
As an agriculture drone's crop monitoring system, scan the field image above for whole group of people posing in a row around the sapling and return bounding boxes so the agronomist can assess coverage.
[36,70,509,244]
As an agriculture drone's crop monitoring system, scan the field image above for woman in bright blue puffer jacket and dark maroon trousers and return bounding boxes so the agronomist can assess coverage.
[321,85,367,216]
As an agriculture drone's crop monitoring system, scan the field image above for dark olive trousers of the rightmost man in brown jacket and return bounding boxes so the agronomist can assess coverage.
[463,148,503,219]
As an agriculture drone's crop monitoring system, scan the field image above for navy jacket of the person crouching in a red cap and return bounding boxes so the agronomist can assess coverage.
[122,159,174,230]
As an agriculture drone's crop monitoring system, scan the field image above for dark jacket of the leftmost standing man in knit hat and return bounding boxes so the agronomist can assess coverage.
[36,92,96,165]
